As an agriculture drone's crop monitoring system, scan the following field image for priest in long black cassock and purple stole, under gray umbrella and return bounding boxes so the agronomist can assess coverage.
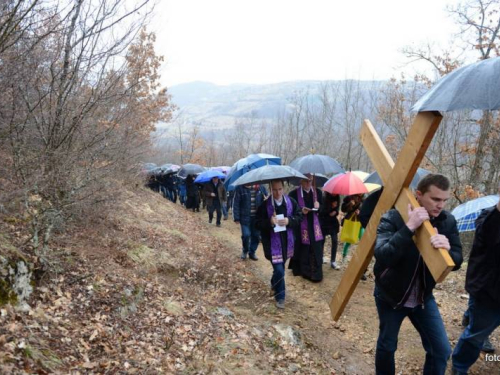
[289,174,323,282]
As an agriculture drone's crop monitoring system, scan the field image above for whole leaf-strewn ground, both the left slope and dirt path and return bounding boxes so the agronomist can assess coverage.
[0,189,500,374]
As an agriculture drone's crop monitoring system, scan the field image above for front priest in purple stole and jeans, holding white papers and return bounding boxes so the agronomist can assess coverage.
[255,180,302,309]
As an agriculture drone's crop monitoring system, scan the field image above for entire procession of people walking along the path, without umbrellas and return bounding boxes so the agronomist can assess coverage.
[146,174,500,374]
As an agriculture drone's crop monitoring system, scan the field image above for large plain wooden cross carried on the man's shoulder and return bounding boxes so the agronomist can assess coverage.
[330,112,455,321]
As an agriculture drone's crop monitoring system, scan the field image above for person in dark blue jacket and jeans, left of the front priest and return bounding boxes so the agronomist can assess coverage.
[233,185,267,260]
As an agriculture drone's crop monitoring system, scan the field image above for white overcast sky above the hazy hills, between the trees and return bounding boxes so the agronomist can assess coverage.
[151,0,456,86]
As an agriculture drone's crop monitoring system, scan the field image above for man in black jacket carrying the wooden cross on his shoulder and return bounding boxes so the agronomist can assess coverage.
[374,174,462,375]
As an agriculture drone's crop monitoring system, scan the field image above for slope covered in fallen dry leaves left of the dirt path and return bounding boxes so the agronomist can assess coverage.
[0,190,340,374]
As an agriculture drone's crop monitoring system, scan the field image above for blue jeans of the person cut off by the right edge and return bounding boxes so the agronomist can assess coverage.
[452,296,500,373]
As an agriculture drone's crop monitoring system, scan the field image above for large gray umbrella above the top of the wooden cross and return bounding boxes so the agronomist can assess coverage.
[412,57,500,112]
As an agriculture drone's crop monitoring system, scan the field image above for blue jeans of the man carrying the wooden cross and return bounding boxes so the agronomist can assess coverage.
[375,295,451,375]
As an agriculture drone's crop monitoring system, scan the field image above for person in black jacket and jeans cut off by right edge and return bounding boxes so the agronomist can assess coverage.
[452,186,500,374]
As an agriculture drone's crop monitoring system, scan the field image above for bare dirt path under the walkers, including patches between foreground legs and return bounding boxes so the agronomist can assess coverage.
[189,212,500,374]
